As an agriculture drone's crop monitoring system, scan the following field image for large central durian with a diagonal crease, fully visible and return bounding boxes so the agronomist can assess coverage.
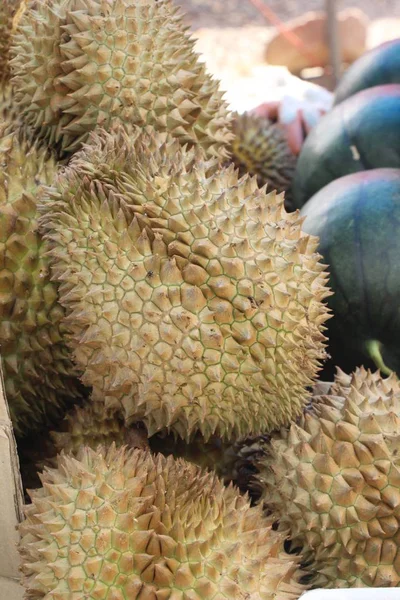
[41,128,328,441]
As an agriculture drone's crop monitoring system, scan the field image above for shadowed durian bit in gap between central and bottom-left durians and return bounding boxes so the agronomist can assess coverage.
[50,396,149,454]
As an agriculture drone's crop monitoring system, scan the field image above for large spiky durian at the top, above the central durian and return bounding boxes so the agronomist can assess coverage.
[11,0,232,159]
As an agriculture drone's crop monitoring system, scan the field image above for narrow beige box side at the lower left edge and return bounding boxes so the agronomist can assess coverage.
[0,361,24,600]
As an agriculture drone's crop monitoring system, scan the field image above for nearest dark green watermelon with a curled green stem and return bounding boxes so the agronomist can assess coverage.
[301,169,400,374]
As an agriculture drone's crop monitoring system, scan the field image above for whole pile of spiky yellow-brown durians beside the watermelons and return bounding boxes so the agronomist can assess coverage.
[0,0,400,600]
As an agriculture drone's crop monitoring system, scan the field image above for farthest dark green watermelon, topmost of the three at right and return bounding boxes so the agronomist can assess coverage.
[334,39,400,104]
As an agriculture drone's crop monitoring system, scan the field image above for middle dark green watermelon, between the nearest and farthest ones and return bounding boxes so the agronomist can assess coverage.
[292,84,400,208]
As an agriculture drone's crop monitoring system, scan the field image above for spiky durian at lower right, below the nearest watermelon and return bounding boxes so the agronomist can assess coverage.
[261,368,400,587]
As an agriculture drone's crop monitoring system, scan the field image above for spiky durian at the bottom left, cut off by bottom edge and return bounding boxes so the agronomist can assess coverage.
[20,447,304,600]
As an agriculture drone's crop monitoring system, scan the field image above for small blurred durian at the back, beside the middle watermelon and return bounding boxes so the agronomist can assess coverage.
[231,113,297,209]
